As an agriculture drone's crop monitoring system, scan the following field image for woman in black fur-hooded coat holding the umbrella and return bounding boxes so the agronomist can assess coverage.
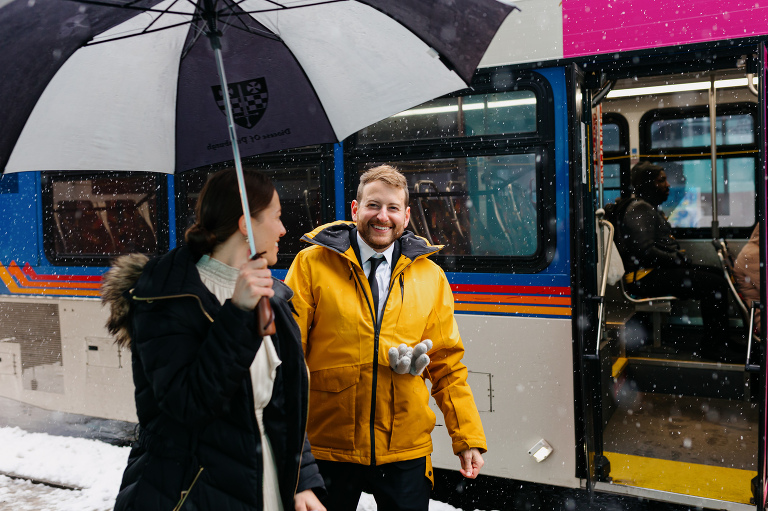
[103,169,325,511]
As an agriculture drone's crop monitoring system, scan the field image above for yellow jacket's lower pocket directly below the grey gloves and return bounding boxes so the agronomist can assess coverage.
[389,372,435,451]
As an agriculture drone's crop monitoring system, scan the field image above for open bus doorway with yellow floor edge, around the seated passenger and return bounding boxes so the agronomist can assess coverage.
[580,44,768,511]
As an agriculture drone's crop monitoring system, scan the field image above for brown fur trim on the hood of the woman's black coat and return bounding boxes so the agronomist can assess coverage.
[101,254,149,348]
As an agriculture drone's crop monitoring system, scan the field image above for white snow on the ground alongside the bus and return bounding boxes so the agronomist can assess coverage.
[0,427,468,511]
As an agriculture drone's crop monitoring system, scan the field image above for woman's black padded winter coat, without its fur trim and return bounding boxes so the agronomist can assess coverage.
[107,247,323,511]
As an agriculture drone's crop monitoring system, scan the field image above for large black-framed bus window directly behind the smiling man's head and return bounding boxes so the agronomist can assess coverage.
[346,70,555,272]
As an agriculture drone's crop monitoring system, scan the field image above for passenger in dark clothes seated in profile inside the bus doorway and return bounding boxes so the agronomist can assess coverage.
[616,161,735,361]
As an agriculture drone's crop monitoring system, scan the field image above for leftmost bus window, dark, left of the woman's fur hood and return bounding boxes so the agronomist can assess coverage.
[43,172,167,266]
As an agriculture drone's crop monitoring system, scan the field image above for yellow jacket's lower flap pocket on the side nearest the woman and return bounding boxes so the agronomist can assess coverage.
[307,366,360,450]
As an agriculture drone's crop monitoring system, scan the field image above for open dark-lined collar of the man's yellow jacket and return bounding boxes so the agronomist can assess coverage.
[301,220,443,268]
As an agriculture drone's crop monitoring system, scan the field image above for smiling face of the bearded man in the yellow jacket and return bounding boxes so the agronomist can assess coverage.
[352,181,411,252]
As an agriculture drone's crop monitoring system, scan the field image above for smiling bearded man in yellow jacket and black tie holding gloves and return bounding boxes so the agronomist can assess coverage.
[286,165,487,511]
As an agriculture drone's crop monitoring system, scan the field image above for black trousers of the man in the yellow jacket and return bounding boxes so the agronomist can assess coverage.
[317,457,432,511]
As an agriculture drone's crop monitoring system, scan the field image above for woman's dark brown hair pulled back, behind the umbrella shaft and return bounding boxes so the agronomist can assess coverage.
[184,168,275,255]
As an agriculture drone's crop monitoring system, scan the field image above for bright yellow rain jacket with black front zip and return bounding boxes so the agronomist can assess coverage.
[285,221,487,468]
